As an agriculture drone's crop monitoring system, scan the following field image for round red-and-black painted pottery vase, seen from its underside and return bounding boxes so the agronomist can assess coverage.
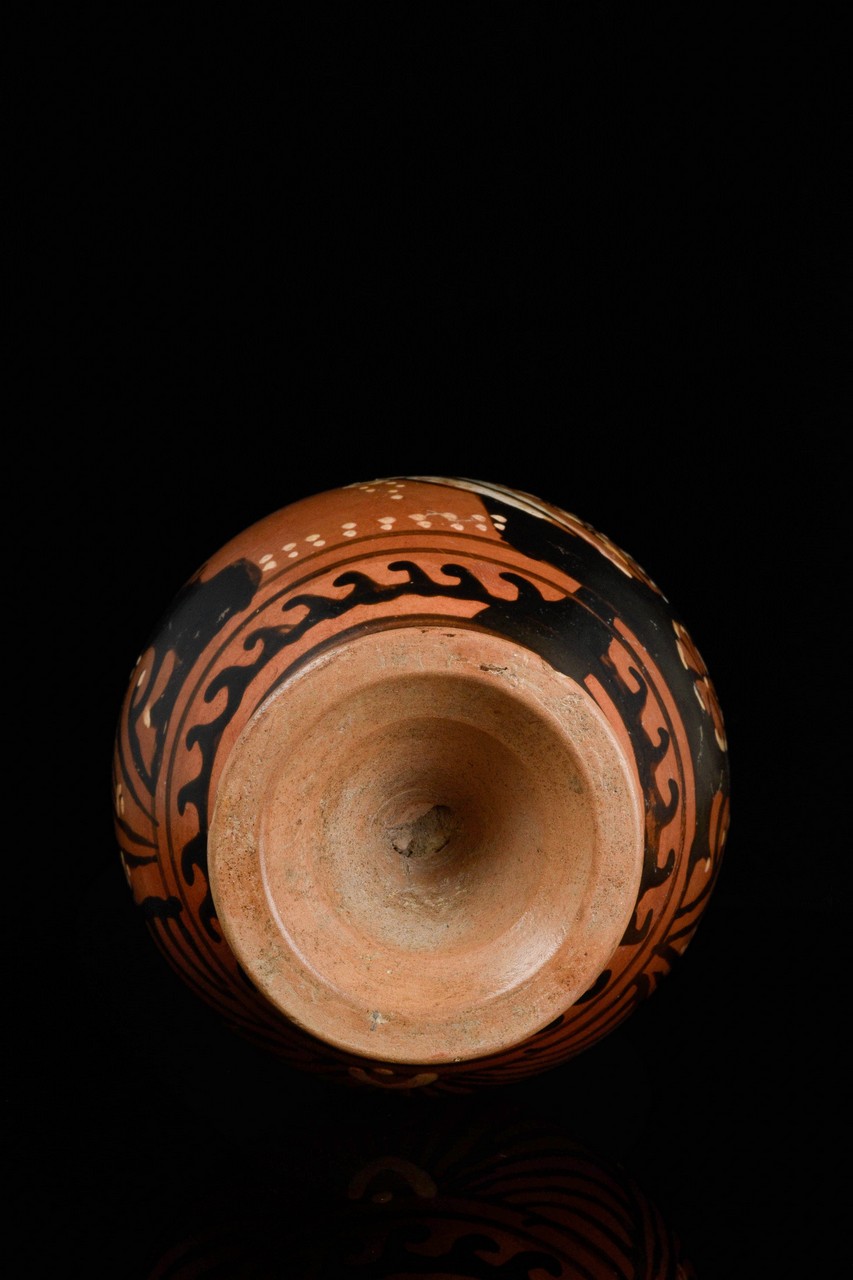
[114,477,729,1092]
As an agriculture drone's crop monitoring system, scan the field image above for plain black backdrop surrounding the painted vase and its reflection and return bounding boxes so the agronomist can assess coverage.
[11,3,850,1280]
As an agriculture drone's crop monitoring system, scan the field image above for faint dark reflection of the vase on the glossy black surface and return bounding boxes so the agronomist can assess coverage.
[147,1115,695,1280]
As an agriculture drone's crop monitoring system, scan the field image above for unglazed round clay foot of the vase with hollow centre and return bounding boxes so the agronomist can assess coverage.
[209,625,644,1064]
